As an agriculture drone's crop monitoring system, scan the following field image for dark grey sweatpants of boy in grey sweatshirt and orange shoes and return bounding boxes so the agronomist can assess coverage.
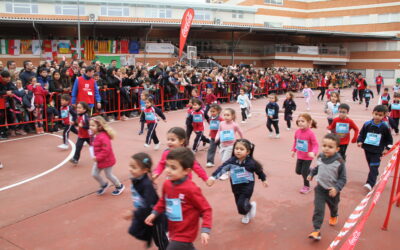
[313,185,340,230]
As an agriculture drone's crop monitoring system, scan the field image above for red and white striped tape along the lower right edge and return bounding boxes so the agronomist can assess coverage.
[328,144,399,250]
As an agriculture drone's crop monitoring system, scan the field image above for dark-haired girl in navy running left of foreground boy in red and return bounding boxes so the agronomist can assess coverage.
[125,153,168,250]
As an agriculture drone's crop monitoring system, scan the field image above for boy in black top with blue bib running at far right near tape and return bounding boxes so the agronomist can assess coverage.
[357,105,393,191]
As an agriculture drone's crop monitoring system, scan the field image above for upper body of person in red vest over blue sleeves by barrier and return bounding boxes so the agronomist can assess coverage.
[72,66,101,110]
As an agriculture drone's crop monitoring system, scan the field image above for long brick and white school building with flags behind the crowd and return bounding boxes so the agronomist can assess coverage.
[0,0,400,85]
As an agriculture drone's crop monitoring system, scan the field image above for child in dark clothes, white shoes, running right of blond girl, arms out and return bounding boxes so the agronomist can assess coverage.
[140,97,167,150]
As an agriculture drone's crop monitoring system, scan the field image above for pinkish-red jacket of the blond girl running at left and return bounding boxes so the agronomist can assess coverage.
[92,131,117,168]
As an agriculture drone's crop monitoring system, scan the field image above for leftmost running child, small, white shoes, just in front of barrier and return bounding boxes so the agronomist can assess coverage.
[57,94,78,149]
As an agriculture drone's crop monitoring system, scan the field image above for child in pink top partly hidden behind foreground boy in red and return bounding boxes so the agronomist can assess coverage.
[153,127,208,181]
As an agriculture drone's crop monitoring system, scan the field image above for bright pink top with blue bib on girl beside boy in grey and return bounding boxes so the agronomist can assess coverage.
[292,128,318,160]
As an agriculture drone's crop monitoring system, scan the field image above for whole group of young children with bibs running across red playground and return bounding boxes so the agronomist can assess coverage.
[50,81,400,250]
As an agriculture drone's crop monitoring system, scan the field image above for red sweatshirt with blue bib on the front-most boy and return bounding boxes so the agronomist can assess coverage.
[154,178,212,242]
